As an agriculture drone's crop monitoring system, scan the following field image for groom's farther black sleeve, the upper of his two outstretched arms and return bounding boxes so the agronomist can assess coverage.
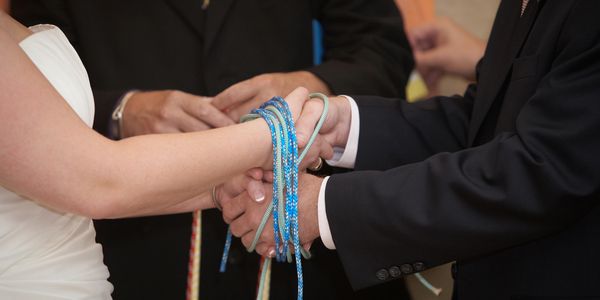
[354,84,476,170]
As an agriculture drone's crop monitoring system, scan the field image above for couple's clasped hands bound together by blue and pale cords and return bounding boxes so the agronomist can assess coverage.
[215,88,351,257]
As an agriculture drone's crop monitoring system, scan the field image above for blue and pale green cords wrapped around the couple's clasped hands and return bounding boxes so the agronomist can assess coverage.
[221,93,329,300]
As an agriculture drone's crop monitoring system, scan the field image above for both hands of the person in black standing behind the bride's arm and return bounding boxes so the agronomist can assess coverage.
[123,71,330,137]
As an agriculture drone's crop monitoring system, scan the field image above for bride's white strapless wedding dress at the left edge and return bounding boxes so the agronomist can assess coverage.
[0,25,113,300]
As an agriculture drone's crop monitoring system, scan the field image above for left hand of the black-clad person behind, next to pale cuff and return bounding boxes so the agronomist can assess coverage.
[122,90,235,137]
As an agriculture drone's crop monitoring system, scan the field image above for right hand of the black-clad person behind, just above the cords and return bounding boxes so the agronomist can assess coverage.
[213,71,330,122]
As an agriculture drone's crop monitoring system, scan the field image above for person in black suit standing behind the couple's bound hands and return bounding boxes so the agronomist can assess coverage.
[12,0,413,299]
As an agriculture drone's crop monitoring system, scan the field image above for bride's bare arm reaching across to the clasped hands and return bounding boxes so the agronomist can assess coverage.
[0,13,319,219]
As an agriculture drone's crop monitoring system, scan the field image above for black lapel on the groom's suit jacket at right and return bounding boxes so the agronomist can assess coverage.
[469,0,539,145]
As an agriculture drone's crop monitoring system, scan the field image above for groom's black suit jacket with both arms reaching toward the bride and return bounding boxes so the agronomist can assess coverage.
[326,0,600,300]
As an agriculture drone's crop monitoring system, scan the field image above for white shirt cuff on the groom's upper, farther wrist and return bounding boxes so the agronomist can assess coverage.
[327,95,360,169]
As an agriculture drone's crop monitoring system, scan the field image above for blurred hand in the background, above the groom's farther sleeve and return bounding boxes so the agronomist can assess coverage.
[409,18,486,93]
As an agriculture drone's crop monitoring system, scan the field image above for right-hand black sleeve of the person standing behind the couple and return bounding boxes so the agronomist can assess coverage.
[309,0,413,97]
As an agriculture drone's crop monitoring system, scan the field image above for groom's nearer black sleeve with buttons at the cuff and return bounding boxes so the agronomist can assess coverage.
[326,1,600,288]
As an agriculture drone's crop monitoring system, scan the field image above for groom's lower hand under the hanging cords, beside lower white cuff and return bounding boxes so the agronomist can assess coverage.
[222,174,323,257]
